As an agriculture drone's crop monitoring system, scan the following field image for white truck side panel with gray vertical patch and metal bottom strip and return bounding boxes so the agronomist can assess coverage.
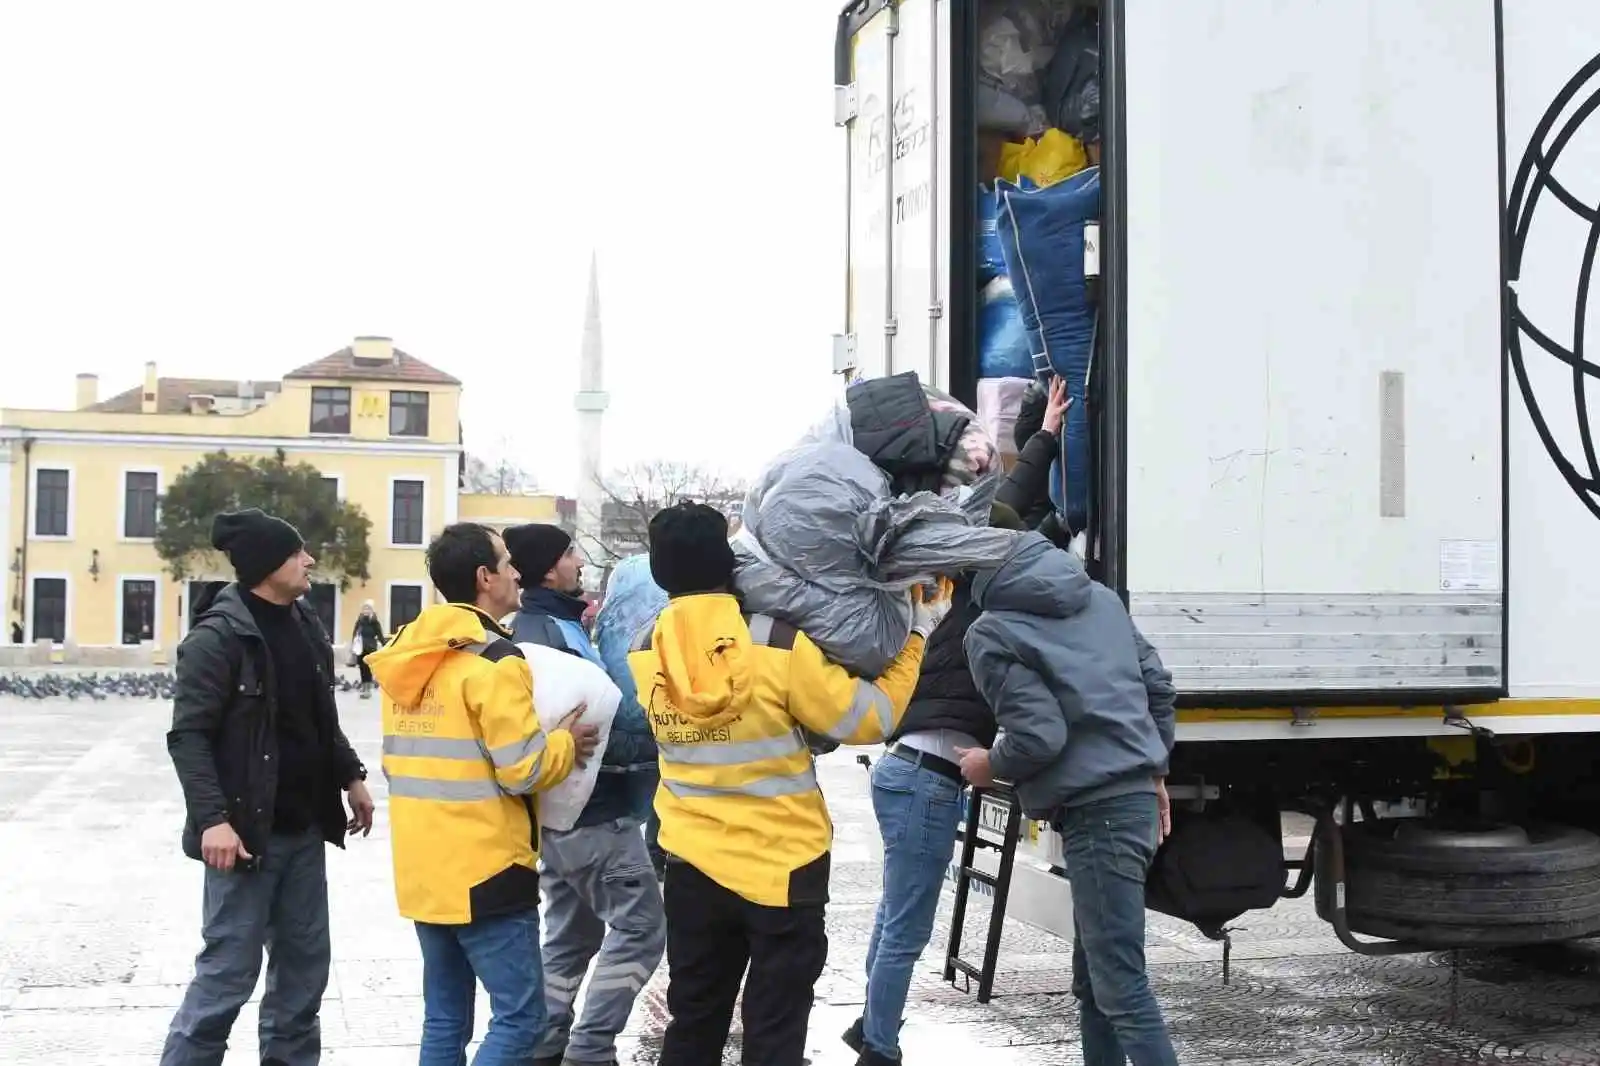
[1123,0,1502,693]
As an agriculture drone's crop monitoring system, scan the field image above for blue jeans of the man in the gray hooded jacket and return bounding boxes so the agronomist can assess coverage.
[1056,792,1178,1066]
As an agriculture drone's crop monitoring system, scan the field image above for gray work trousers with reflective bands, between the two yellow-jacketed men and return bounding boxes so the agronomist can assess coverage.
[539,818,667,1063]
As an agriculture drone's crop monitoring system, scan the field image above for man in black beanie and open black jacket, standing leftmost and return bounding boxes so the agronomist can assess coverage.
[162,509,373,1066]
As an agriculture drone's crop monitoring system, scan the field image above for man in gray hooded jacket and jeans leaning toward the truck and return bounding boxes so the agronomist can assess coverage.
[960,533,1178,1066]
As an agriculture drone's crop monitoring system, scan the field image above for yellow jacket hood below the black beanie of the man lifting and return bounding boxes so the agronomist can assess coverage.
[651,594,754,728]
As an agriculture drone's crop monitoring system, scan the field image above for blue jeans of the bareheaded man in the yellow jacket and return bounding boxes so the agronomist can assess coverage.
[416,908,544,1066]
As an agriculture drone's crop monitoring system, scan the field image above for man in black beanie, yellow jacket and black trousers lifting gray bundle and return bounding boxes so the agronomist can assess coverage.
[629,504,950,1066]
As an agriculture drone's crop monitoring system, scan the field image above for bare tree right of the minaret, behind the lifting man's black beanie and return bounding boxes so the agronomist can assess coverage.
[584,459,749,570]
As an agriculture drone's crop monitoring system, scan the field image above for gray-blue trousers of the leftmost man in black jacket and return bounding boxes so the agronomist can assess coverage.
[162,829,331,1066]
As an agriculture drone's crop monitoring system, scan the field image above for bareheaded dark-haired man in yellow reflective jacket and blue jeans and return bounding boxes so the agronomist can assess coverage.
[366,522,597,1066]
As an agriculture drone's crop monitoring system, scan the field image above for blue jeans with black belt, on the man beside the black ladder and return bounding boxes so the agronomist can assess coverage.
[862,754,962,1058]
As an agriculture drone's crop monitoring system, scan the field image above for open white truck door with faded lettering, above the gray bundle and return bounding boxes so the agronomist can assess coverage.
[835,0,954,389]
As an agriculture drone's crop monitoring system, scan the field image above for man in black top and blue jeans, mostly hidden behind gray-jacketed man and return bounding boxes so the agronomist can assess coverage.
[843,504,1022,1066]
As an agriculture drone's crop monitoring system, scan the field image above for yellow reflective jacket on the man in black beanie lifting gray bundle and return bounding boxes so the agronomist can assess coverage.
[629,595,923,908]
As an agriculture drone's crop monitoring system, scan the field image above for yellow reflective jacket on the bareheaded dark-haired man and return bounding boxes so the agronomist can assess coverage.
[366,603,576,925]
